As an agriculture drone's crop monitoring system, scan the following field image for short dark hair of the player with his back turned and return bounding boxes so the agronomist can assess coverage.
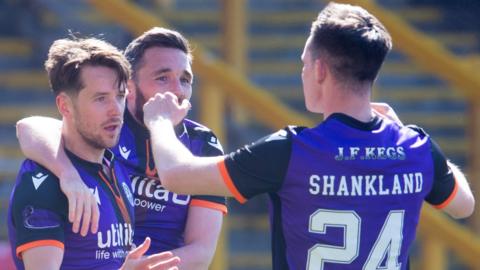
[309,3,392,82]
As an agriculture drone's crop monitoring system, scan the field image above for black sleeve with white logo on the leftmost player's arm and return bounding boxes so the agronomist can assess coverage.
[11,167,68,251]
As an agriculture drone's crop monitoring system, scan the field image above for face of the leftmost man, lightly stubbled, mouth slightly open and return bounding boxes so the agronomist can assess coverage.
[72,66,126,149]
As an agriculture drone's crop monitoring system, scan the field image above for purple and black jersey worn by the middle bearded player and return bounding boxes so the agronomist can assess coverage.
[112,110,227,254]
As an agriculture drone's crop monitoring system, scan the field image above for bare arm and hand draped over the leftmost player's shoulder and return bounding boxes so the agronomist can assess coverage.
[17,116,99,236]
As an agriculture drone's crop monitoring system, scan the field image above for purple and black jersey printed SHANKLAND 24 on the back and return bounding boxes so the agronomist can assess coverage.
[219,113,456,270]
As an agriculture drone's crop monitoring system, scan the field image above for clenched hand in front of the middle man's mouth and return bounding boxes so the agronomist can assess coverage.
[143,92,191,127]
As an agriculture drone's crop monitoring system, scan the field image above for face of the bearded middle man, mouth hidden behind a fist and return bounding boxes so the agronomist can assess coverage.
[130,47,193,121]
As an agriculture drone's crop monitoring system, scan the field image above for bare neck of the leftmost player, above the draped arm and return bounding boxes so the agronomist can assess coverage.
[62,118,105,164]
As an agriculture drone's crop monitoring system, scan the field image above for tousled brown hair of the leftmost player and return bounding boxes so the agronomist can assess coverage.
[45,37,130,95]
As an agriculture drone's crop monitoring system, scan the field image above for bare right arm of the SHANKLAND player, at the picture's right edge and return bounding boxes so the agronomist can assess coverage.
[443,162,475,218]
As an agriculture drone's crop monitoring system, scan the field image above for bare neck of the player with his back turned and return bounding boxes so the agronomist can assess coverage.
[323,80,374,122]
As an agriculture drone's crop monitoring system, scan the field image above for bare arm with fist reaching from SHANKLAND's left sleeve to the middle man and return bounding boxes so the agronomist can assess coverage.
[143,93,232,196]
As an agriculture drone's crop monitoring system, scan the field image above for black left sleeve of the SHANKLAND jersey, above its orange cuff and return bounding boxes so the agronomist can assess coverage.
[225,127,298,199]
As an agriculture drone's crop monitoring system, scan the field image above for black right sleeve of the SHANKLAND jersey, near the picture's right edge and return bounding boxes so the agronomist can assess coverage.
[425,140,455,205]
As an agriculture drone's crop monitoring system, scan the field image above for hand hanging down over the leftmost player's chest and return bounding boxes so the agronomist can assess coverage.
[60,171,100,236]
